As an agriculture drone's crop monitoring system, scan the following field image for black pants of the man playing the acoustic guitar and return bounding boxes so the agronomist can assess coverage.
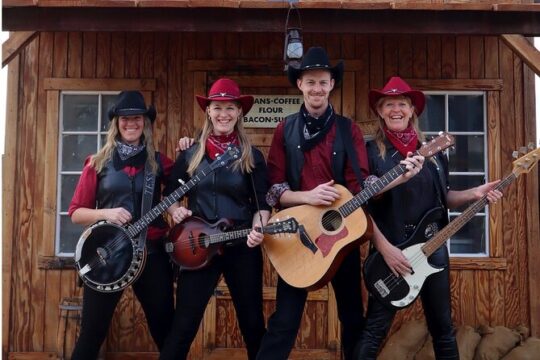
[257,248,364,360]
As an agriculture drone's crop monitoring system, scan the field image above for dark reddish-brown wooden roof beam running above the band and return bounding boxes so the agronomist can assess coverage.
[2,5,540,36]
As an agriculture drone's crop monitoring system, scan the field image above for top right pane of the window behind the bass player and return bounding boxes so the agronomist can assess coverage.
[448,95,484,132]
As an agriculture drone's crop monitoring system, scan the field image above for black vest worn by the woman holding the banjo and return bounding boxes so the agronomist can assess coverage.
[96,152,167,228]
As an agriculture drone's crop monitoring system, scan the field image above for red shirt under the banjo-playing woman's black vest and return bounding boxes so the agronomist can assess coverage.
[68,153,174,240]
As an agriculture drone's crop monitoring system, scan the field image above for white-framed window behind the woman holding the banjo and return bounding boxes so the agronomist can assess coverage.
[55,91,117,256]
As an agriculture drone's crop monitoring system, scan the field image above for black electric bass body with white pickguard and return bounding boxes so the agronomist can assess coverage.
[364,208,446,309]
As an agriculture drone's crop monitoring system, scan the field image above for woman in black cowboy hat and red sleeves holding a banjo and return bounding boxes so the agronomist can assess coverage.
[69,91,174,360]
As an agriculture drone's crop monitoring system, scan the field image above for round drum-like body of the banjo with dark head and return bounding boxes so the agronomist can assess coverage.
[75,221,146,292]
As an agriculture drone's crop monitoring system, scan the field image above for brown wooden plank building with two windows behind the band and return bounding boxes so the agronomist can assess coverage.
[2,0,540,359]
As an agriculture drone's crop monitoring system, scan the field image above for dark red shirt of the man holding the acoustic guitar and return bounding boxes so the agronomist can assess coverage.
[268,117,369,202]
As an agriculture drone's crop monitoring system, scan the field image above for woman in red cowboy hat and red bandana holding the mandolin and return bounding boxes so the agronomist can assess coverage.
[160,79,270,360]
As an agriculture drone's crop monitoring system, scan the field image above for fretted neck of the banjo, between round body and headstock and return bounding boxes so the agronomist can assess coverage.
[127,168,212,237]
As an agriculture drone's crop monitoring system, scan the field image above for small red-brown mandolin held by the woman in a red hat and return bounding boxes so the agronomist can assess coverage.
[165,216,298,270]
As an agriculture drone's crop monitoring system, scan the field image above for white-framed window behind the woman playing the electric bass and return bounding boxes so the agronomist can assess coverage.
[420,91,489,256]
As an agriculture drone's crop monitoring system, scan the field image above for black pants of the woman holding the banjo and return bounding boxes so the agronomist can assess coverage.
[71,251,174,360]
